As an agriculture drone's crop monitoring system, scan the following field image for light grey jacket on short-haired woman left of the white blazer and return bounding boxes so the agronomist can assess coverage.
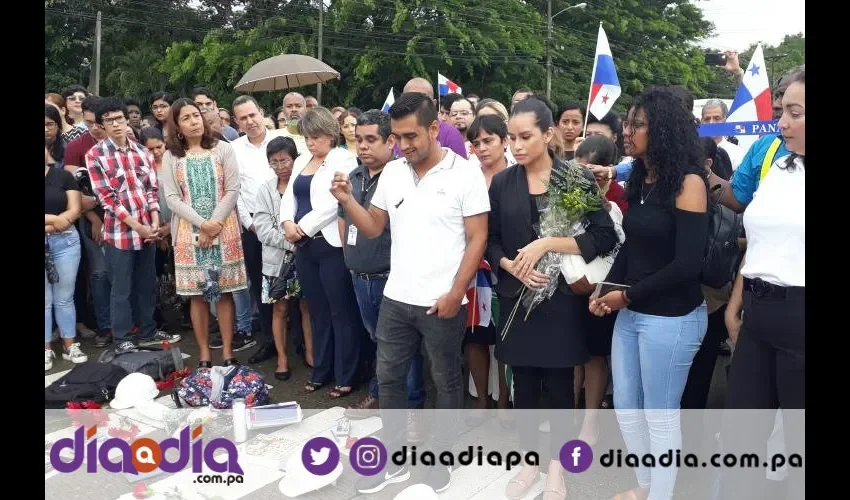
[254,176,294,277]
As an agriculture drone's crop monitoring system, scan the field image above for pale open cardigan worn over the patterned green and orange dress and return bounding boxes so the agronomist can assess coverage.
[160,141,239,241]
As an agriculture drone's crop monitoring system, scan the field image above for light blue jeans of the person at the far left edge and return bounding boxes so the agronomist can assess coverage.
[44,230,80,344]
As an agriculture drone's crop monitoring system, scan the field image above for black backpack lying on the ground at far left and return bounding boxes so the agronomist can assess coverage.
[44,362,127,409]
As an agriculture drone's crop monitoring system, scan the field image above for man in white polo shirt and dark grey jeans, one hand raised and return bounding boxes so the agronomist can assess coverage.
[331,92,490,493]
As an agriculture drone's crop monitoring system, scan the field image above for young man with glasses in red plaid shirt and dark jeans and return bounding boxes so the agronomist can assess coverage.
[86,98,180,355]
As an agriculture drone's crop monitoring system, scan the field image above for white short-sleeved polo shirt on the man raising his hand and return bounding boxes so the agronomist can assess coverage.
[372,148,490,307]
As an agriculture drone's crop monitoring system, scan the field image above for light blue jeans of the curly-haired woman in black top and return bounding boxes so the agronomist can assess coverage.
[611,302,708,500]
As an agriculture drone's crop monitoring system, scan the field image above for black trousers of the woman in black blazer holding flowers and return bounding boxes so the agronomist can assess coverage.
[511,366,575,460]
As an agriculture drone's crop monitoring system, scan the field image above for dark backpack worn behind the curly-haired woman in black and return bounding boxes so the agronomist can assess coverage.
[700,185,744,288]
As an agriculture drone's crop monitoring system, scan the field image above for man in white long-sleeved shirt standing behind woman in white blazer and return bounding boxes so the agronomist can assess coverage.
[231,95,283,364]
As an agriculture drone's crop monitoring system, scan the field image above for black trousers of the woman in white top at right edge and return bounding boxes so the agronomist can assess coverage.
[721,288,806,500]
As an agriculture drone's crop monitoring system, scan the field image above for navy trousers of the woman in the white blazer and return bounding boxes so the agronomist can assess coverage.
[295,238,367,387]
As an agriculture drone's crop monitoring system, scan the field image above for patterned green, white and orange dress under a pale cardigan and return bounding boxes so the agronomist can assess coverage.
[173,149,248,295]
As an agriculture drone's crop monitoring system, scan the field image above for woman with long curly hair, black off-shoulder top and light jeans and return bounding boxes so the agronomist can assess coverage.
[590,89,708,500]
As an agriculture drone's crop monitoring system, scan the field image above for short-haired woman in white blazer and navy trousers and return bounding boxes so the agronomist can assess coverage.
[280,108,367,399]
